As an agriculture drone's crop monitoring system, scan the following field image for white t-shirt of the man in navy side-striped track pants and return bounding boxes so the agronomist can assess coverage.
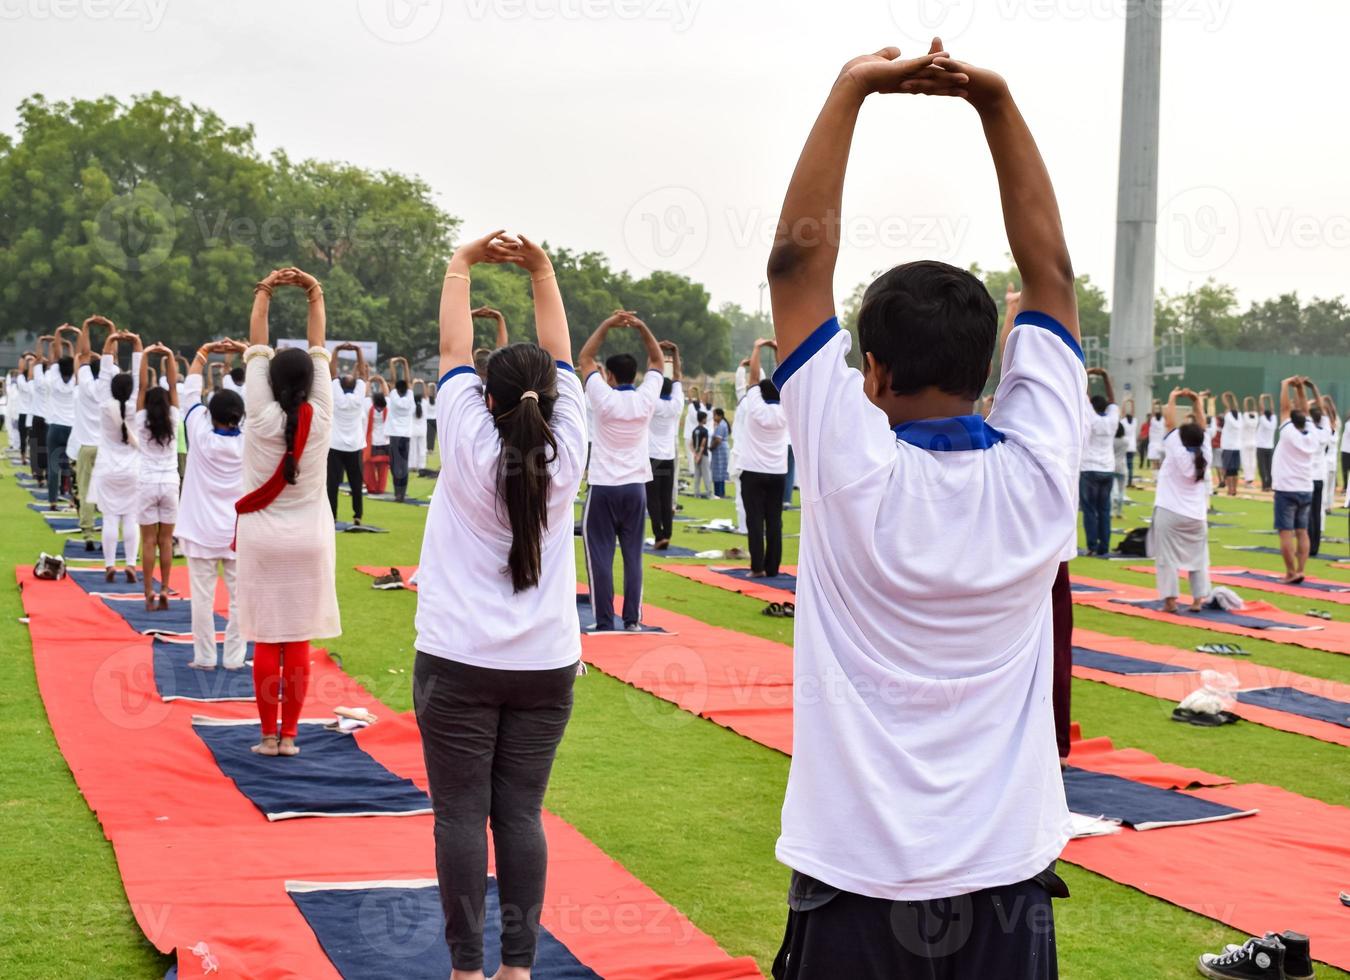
[586,371,664,486]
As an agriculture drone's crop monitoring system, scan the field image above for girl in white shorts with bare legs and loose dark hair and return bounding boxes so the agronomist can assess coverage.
[135,344,178,610]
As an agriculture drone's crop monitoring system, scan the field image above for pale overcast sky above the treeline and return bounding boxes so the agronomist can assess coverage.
[0,0,1350,309]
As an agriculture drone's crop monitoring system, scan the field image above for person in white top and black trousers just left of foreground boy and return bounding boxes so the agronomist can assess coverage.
[736,340,787,579]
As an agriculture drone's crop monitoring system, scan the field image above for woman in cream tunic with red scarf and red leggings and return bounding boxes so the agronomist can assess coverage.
[235,269,342,756]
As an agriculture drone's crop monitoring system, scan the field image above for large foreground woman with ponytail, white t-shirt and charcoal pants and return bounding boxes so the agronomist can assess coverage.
[413,231,586,980]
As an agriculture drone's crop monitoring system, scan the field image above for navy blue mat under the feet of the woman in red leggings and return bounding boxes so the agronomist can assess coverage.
[192,715,431,821]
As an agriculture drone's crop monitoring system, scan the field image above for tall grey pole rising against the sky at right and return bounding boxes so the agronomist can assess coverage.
[1108,0,1162,414]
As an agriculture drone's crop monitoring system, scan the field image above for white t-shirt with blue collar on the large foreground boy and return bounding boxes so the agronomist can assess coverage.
[774,312,1091,900]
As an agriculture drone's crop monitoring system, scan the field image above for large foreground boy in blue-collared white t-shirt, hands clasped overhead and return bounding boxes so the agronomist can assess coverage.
[768,40,1087,980]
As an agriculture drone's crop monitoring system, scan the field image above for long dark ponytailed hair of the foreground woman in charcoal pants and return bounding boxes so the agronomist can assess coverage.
[486,344,558,593]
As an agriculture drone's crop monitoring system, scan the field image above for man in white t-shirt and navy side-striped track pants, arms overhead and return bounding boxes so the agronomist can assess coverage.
[576,309,666,632]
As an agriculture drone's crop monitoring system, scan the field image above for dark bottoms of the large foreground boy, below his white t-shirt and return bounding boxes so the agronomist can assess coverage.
[774,867,1069,980]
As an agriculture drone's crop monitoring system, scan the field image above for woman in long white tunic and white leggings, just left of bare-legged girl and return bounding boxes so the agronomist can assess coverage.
[90,332,143,582]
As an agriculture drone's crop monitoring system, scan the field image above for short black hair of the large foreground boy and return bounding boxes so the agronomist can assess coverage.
[857,261,999,401]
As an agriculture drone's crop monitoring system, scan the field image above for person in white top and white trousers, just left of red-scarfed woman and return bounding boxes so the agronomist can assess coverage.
[177,337,247,671]
